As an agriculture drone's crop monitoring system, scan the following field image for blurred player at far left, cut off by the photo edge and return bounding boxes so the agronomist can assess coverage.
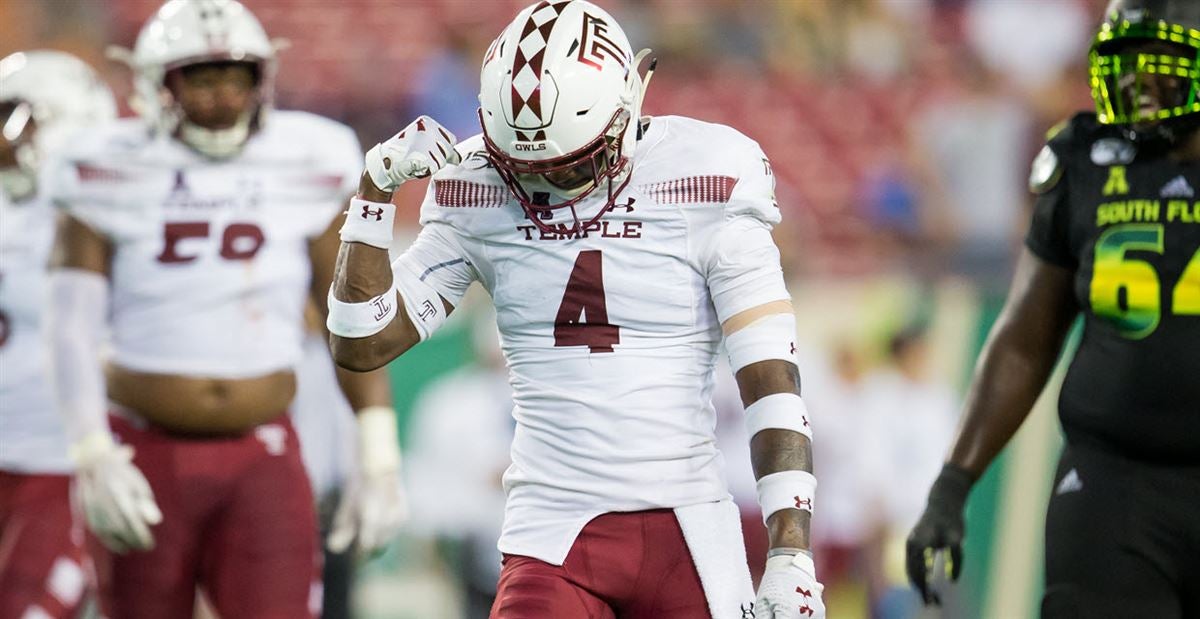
[0,50,116,618]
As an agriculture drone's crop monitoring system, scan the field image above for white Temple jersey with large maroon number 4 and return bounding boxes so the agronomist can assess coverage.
[394,116,790,564]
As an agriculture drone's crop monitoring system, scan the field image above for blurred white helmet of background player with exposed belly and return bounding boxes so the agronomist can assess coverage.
[120,0,280,158]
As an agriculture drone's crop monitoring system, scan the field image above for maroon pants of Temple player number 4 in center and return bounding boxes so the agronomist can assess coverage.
[491,510,710,619]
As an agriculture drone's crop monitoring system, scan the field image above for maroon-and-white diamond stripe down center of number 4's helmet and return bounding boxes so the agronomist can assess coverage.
[510,0,570,130]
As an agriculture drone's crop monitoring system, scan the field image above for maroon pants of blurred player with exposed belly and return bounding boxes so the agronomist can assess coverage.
[89,415,317,619]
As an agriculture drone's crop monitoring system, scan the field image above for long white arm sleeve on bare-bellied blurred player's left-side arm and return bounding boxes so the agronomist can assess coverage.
[49,269,108,443]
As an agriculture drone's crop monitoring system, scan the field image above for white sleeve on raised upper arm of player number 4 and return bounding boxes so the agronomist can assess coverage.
[391,222,479,339]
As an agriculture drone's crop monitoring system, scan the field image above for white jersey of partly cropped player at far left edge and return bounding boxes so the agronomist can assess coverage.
[0,193,71,473]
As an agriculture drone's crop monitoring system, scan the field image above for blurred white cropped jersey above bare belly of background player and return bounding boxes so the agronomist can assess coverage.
[53,112,362,378]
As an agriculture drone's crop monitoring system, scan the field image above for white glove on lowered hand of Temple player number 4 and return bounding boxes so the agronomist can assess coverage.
[754,552,824,619]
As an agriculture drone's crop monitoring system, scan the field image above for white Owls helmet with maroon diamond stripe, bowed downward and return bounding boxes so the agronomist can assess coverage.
[479,0,649,229]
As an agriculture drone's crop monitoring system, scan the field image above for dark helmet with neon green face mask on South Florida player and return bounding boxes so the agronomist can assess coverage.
[1090,0,1200,143]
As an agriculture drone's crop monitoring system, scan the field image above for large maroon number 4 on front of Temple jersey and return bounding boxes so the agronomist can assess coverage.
[554,250,620,353]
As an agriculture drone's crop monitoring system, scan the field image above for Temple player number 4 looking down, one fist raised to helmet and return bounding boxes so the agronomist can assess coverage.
[329,0,824,619]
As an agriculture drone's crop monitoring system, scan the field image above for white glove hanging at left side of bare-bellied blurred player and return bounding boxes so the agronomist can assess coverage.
[71,431,162,553]
